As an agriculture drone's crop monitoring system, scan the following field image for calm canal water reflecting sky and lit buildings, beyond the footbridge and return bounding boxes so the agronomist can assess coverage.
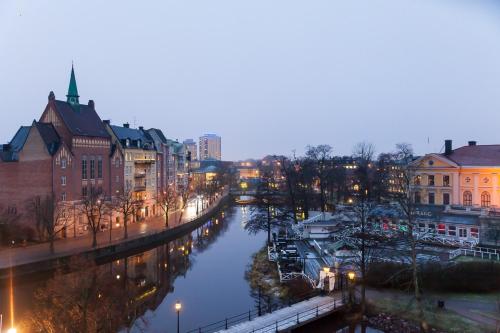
[0,206,266,333]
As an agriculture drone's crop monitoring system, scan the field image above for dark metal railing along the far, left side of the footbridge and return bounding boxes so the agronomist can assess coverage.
[186,291,318,333]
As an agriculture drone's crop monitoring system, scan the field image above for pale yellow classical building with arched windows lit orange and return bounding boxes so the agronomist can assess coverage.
[413,140,500,208]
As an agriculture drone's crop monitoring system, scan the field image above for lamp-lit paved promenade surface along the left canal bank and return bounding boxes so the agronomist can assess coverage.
[0,195,225,269]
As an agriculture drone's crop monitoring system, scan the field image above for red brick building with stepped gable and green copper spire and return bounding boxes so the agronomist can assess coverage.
[0,68,114,236]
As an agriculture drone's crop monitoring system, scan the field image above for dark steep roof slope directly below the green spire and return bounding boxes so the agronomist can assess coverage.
[54,100,109,138]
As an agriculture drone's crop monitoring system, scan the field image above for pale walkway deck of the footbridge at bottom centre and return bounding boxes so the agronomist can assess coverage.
[219,294,342,333]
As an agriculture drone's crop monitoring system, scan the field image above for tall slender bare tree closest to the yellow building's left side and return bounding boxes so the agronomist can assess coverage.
[392,143,428,332]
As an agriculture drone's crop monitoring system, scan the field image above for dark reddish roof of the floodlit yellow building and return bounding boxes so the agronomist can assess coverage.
[440,145,500,166]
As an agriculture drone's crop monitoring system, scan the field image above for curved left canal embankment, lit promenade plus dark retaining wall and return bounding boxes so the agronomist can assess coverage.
[0,193,230,279]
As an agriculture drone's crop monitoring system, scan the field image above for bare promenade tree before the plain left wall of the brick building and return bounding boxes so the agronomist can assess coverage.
[27,195,69,253]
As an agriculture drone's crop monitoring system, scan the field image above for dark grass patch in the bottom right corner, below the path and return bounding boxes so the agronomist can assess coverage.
[370,298,491,333]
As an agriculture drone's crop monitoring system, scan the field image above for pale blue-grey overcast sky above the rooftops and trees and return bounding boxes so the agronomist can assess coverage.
[0,0,500,160]
